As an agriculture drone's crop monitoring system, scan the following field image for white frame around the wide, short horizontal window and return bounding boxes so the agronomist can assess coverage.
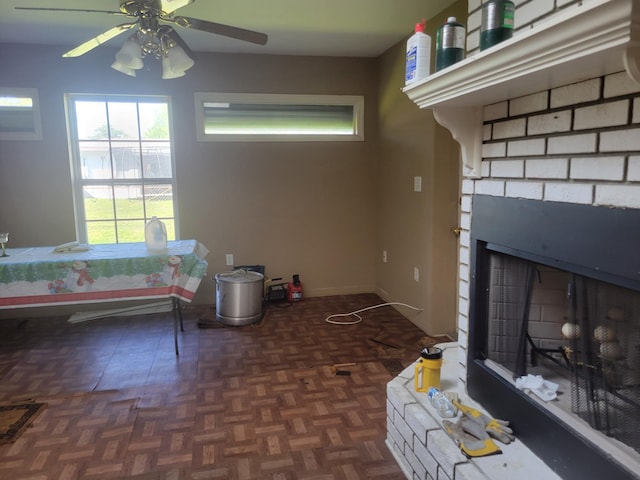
[194,92,364,142]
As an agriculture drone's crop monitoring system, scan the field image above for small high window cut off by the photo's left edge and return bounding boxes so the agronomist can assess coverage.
[0,88,42,140]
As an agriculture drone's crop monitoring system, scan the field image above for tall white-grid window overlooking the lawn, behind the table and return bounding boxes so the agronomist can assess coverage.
[67,95,177,244]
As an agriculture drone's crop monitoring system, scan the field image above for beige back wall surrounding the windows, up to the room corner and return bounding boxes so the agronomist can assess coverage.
[0,45,377,303]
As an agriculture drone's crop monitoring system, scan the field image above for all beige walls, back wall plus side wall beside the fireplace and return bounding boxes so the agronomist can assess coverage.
[0,0,466,334]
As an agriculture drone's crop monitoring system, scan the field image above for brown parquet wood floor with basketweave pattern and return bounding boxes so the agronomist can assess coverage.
[0,295,442,480]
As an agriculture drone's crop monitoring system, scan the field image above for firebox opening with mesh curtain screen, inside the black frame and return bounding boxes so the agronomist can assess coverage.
[487,252,640,452]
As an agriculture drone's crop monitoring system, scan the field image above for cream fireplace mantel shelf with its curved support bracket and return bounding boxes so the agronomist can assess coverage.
[403,0,640,177]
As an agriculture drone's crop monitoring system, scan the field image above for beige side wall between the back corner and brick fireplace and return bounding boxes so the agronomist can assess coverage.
[376,0,467,336]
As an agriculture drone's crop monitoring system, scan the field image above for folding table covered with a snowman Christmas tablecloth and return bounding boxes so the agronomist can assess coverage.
[0,240,209,353]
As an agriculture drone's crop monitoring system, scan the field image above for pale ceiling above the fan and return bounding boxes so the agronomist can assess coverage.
[0,0,456,57]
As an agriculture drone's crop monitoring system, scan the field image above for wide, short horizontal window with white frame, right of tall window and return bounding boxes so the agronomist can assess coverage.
[195,93,364,142]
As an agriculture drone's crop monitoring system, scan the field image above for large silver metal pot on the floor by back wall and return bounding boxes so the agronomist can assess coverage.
[215,270,264,326]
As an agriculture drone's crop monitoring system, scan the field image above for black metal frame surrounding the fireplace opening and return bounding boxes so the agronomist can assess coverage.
[467,195,640,480]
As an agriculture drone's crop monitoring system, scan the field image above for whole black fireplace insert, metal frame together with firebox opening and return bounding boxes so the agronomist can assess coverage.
[467,195,640,479]
